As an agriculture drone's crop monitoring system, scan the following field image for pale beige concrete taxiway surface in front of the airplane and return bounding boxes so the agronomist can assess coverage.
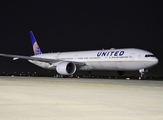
[0,76,163,120]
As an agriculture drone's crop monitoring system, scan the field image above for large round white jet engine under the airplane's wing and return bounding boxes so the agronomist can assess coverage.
[56,62,76,75]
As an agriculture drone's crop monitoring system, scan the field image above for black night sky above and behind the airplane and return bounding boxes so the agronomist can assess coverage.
[0,0,163,76]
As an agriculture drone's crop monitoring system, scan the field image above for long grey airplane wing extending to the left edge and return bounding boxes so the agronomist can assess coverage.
[0,54,84,65]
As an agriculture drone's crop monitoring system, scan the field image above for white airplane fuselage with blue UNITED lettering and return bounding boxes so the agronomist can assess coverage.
[29,48,158,71]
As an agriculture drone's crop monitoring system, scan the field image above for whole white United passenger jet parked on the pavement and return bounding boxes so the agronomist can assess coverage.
[0,31,158,79]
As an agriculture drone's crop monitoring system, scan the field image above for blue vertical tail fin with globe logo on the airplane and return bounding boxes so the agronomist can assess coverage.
[29,31,42,55]
